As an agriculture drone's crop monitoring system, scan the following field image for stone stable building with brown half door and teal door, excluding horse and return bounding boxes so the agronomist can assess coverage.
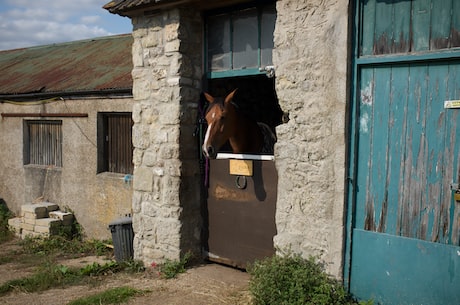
[105,0,460,304]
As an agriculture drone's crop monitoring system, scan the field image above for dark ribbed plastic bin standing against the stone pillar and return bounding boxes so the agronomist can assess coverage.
[109,217,134,262]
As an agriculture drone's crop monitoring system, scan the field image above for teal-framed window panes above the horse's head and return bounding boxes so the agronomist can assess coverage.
[206,5,276,78]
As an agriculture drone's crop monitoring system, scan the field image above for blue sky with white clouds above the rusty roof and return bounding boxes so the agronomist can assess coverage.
[0,0,132,50]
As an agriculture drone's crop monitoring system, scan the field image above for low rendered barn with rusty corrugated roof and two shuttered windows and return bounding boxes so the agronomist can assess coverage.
[0,34,133,239]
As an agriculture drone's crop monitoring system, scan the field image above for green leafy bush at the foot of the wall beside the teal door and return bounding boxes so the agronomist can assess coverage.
[248,254,372,305]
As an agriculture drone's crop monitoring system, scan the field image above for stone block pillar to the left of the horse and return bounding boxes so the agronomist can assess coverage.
[132,9,202,264]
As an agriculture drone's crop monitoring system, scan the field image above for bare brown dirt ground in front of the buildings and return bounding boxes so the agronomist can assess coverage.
[0,241,250,305]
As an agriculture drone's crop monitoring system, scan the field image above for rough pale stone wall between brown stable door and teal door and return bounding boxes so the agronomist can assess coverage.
[273,0,348,276]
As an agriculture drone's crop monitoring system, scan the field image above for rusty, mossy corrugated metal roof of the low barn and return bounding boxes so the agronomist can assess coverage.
[0,34,133,95]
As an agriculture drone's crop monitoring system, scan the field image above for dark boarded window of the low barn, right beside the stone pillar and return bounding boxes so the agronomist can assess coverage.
[98,112,133,174]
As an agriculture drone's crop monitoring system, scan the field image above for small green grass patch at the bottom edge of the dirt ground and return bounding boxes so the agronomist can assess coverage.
[67,287,146,305]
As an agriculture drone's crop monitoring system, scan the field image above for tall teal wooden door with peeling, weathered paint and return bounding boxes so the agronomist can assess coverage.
[344,0,460,305]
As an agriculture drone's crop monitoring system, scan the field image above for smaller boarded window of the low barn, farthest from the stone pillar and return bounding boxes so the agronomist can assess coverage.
[24,121,62,167]
